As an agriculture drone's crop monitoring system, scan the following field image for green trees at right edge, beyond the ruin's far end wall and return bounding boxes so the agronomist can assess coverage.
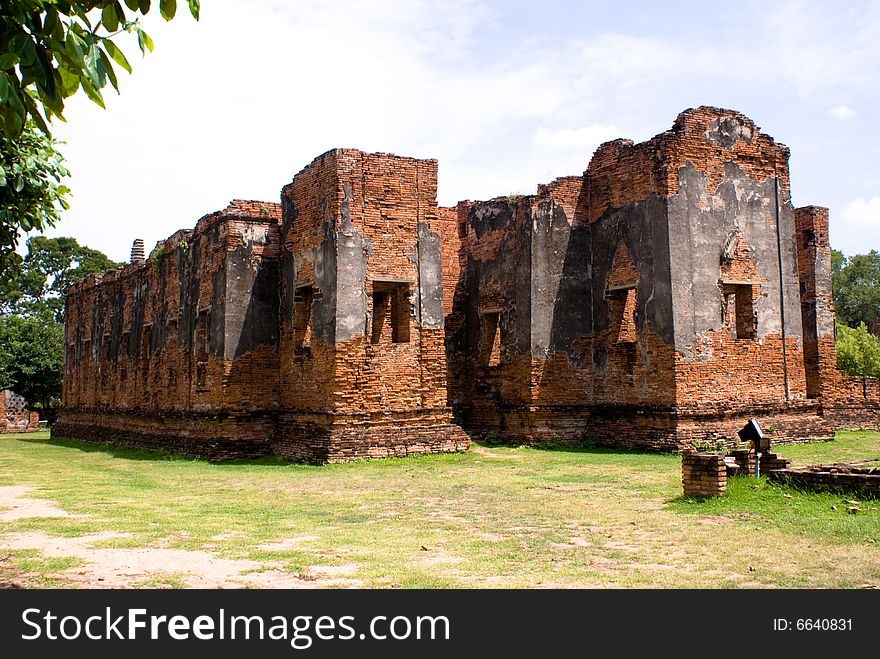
[831,250,880,328]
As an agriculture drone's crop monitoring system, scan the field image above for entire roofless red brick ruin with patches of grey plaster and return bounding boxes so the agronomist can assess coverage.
[53,107,880,462]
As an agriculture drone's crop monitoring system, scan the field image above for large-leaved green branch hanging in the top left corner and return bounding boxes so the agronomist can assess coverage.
[0,0,199,137]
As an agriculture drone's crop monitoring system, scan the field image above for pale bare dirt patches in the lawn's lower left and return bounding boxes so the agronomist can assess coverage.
[0,486,361,588]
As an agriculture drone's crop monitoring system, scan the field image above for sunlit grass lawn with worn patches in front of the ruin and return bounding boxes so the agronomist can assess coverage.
[0,432,880,588]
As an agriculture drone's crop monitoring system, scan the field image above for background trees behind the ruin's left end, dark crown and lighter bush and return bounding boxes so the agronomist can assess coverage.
[0,236,120,408]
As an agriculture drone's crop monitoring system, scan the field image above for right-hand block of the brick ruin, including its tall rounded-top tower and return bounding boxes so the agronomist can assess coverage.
[447,108,830,447]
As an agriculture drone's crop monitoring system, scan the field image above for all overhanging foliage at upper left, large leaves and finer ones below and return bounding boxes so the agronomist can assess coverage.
[0,0,200,277]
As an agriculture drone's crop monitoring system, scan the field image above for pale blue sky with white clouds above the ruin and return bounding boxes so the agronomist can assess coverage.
[43,0,880,260]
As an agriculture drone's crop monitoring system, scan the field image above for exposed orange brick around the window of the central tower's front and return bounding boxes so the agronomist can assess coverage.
[336,150,446,413]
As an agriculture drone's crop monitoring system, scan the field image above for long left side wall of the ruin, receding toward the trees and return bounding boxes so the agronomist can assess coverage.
[53,200,280,455]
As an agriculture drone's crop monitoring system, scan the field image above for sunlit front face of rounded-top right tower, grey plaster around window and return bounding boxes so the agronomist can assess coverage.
[664,108,806,409]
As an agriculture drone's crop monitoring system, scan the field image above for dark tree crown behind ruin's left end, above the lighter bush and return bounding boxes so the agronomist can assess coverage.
[0,236,122,322]
